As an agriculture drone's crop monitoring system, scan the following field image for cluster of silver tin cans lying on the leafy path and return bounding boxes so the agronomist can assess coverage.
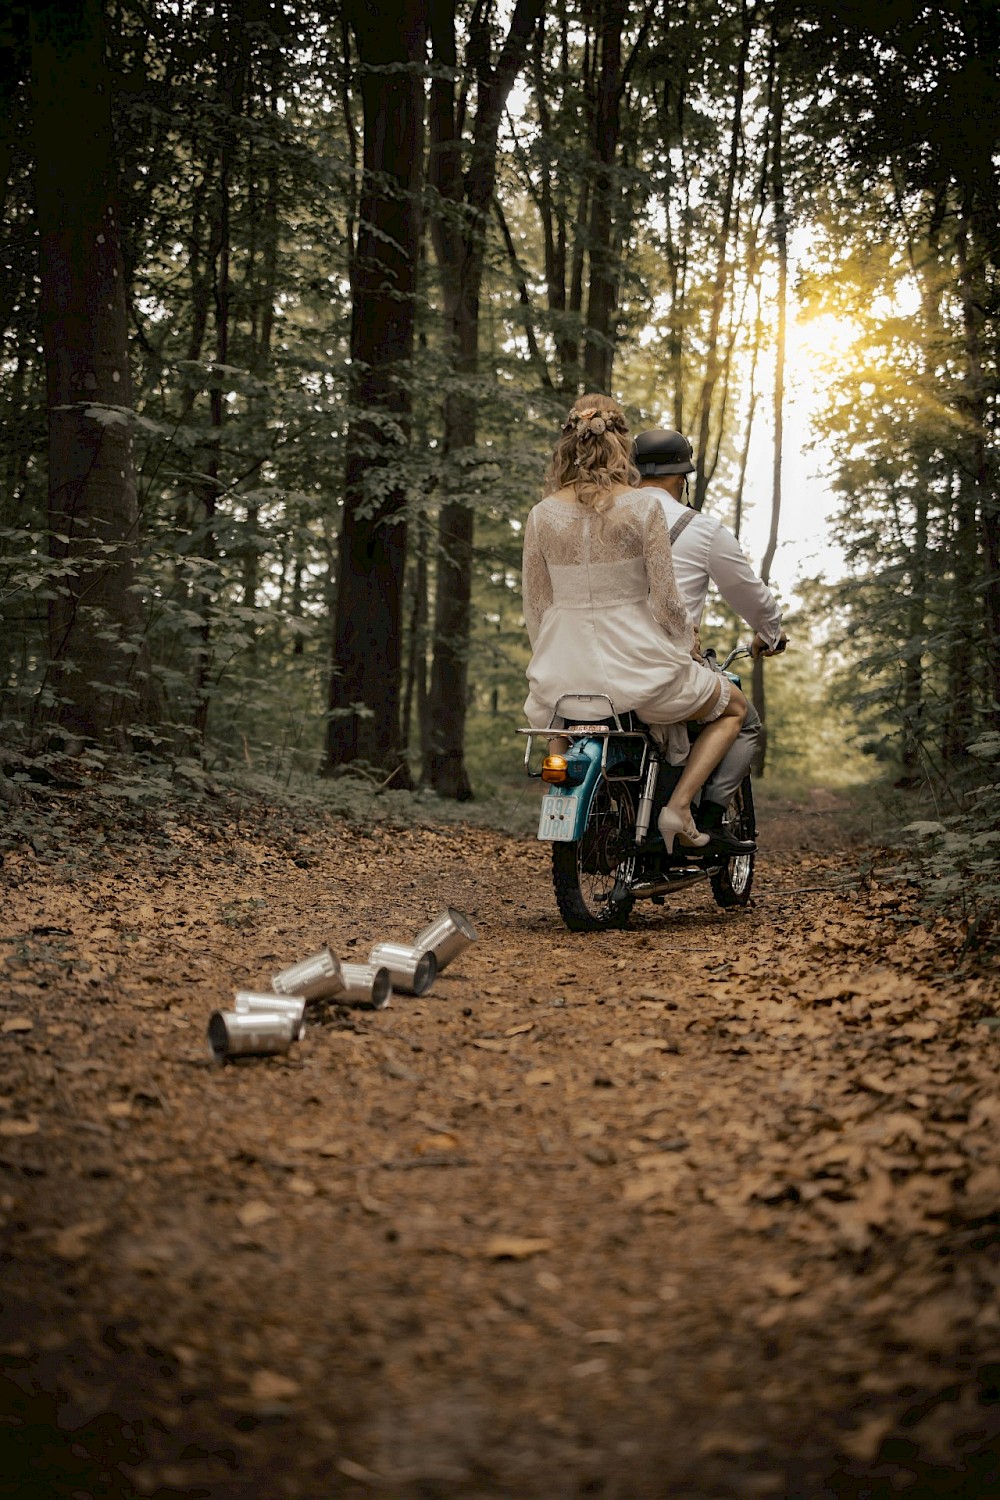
[208,906,478,1064]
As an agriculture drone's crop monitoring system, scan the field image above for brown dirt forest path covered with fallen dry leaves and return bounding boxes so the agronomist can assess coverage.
[0,792,1000,1500]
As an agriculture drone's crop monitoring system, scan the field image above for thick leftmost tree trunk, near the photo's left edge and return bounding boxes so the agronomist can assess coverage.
[30,0,157,740]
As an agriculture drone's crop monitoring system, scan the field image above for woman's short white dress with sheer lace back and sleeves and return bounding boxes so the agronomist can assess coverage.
[522,489,729,747]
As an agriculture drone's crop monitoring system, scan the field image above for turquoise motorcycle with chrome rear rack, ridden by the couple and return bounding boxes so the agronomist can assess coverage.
[519,647,757,932]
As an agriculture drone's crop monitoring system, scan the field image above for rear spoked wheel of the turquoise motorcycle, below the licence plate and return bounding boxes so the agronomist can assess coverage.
[552,782,636,933]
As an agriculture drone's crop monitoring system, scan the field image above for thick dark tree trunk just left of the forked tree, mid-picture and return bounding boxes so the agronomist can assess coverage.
[327,0,426,786]
